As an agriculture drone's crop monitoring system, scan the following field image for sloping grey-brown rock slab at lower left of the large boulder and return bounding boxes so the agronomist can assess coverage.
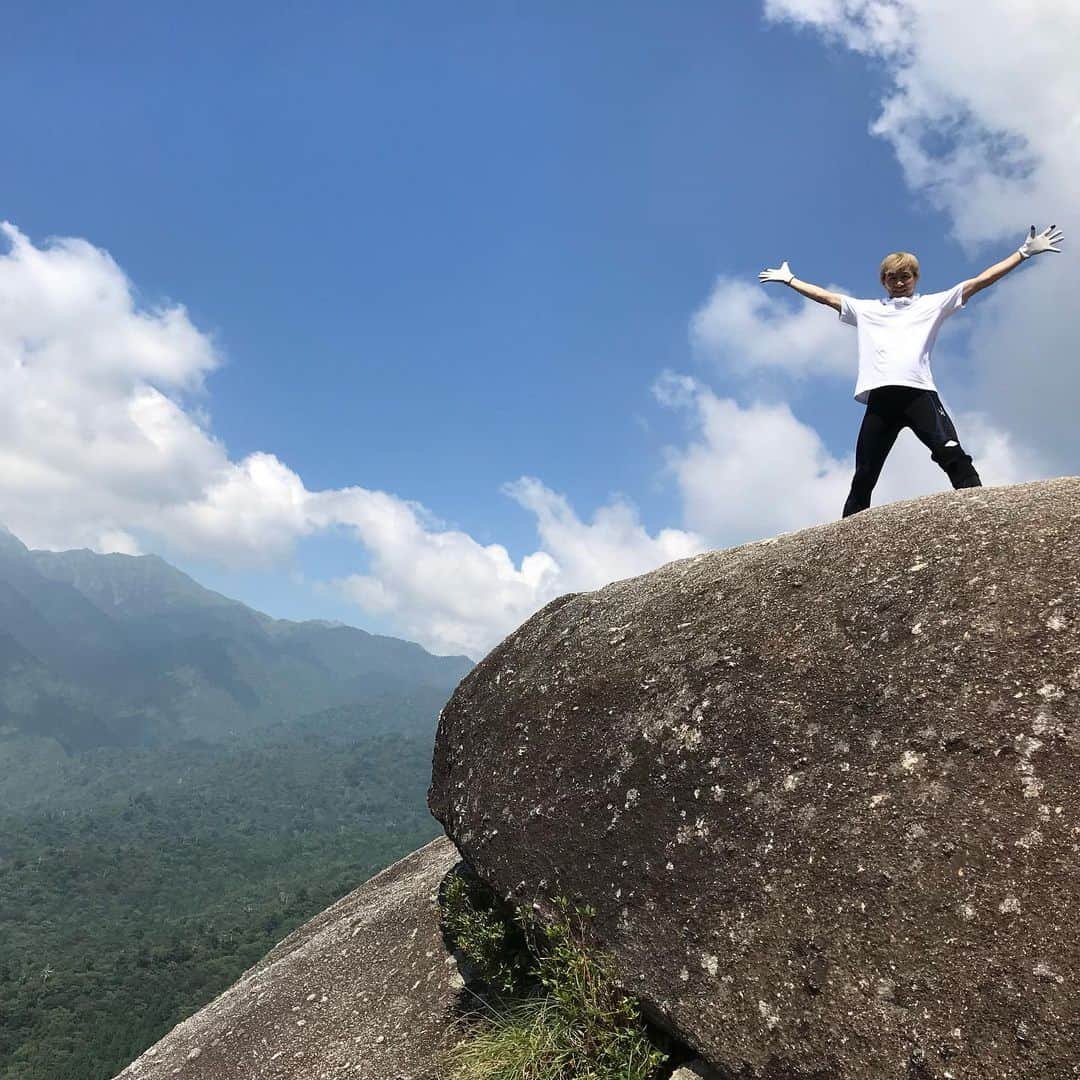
[116,838,462,1080]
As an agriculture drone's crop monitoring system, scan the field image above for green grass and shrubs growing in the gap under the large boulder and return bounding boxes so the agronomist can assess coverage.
[443,875,667,1080]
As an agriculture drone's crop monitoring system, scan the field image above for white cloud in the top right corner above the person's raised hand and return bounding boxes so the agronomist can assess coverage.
[765,0,1080,244]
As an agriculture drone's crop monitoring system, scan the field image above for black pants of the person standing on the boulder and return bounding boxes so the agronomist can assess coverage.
[843,387,983,517]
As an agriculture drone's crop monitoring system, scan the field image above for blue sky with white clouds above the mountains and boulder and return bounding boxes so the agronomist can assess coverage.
[0,0,1077,654]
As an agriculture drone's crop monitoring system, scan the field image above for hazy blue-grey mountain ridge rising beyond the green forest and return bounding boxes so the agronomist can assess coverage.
[0,530,471,752]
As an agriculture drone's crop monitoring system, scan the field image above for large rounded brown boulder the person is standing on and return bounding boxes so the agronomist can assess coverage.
[430,478,1080,1080]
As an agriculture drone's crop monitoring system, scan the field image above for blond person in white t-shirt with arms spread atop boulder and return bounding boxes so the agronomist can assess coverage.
[758,225,1063,517]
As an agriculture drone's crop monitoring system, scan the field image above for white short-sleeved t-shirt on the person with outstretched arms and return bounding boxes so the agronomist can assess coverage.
[840,282,963,403]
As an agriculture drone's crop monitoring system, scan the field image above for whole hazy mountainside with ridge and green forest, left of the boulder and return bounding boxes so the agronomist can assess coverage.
[0,529,471,1080]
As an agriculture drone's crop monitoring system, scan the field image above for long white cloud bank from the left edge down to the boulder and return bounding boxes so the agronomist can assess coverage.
[0,225,701,657]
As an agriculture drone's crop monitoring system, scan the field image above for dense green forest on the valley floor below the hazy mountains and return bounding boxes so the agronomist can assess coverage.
[0,725,438,1080]
